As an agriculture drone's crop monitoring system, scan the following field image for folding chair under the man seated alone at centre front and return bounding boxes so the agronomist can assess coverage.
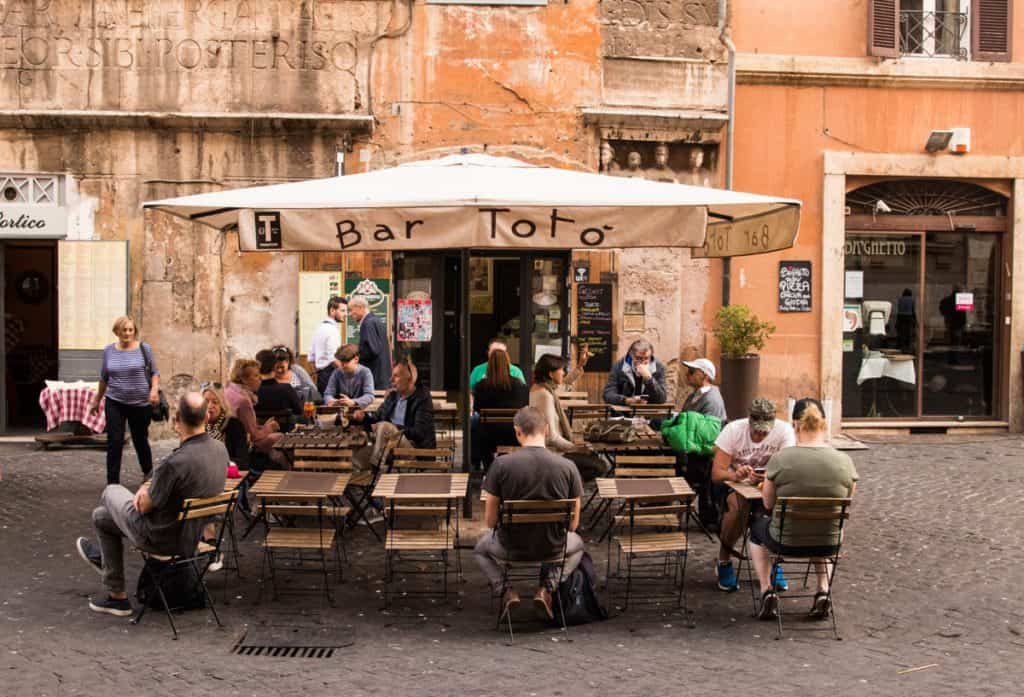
[492,498,577,641]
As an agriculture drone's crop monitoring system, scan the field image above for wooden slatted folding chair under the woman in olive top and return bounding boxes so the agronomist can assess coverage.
[768,496,852,640]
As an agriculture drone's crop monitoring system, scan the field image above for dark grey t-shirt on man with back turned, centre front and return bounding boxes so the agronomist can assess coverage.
[483,447,583,559]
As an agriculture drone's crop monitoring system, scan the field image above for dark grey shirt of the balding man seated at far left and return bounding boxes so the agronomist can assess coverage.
[143,433,227,553]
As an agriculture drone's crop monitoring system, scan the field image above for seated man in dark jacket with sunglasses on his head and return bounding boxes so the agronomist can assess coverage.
[352,361,437,470]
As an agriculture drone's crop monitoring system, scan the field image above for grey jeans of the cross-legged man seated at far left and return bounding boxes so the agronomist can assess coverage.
[92,484,159,593]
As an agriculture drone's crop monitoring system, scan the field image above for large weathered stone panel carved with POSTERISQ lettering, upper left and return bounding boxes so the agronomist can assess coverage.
[0,0,390,112]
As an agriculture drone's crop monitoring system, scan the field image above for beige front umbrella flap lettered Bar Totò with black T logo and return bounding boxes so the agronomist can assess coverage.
[239,206,707,251]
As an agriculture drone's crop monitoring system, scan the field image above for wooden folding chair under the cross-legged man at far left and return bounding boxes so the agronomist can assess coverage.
[131,490,239,639]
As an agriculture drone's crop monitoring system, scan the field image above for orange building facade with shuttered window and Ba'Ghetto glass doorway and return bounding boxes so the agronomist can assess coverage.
[731,0,1024,431]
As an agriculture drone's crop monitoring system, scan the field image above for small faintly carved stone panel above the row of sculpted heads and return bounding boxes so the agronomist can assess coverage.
[601,0,718,58]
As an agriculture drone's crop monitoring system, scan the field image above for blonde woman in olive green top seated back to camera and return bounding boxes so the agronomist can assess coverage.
[751,397,857,619]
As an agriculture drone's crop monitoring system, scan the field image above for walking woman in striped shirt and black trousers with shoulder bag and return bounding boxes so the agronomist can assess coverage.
[89,315,160,484]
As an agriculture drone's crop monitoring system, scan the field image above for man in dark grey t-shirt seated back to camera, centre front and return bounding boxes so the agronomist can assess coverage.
[473,406,583,619]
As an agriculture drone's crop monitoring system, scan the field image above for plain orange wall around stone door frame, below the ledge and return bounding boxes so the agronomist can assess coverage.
[732,80,1024,407]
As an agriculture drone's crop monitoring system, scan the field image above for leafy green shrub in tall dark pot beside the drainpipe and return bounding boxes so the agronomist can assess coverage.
[712,305,775,420]
